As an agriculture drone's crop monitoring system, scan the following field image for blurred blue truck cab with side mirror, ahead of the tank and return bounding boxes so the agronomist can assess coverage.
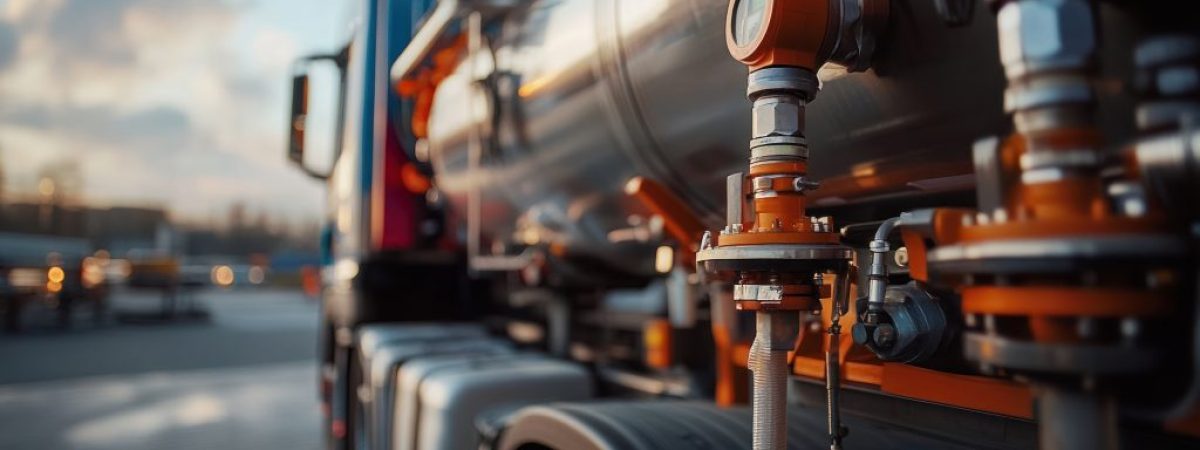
[288,0,478,449]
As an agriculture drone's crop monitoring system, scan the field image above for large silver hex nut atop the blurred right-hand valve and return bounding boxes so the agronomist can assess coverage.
[996,0,1096,78]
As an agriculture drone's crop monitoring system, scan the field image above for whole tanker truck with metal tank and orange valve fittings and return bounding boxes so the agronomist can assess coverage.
[288,0,1200,449]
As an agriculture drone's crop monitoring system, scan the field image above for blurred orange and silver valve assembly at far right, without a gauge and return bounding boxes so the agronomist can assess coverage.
[923,0,1192,449]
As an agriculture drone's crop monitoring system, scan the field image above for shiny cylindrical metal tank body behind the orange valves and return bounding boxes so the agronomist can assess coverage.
[428,0,1132,278]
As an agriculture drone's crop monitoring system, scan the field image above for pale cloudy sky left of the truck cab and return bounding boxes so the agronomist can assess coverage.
[0,0,348,225]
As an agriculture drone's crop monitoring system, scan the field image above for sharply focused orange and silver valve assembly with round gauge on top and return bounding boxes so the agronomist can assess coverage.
[696,0,887,450]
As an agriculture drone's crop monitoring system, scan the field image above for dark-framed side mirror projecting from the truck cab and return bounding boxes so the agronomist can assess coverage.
[288,52,346,180]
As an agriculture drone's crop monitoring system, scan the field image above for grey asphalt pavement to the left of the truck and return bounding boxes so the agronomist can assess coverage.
[0,289,320,450]
